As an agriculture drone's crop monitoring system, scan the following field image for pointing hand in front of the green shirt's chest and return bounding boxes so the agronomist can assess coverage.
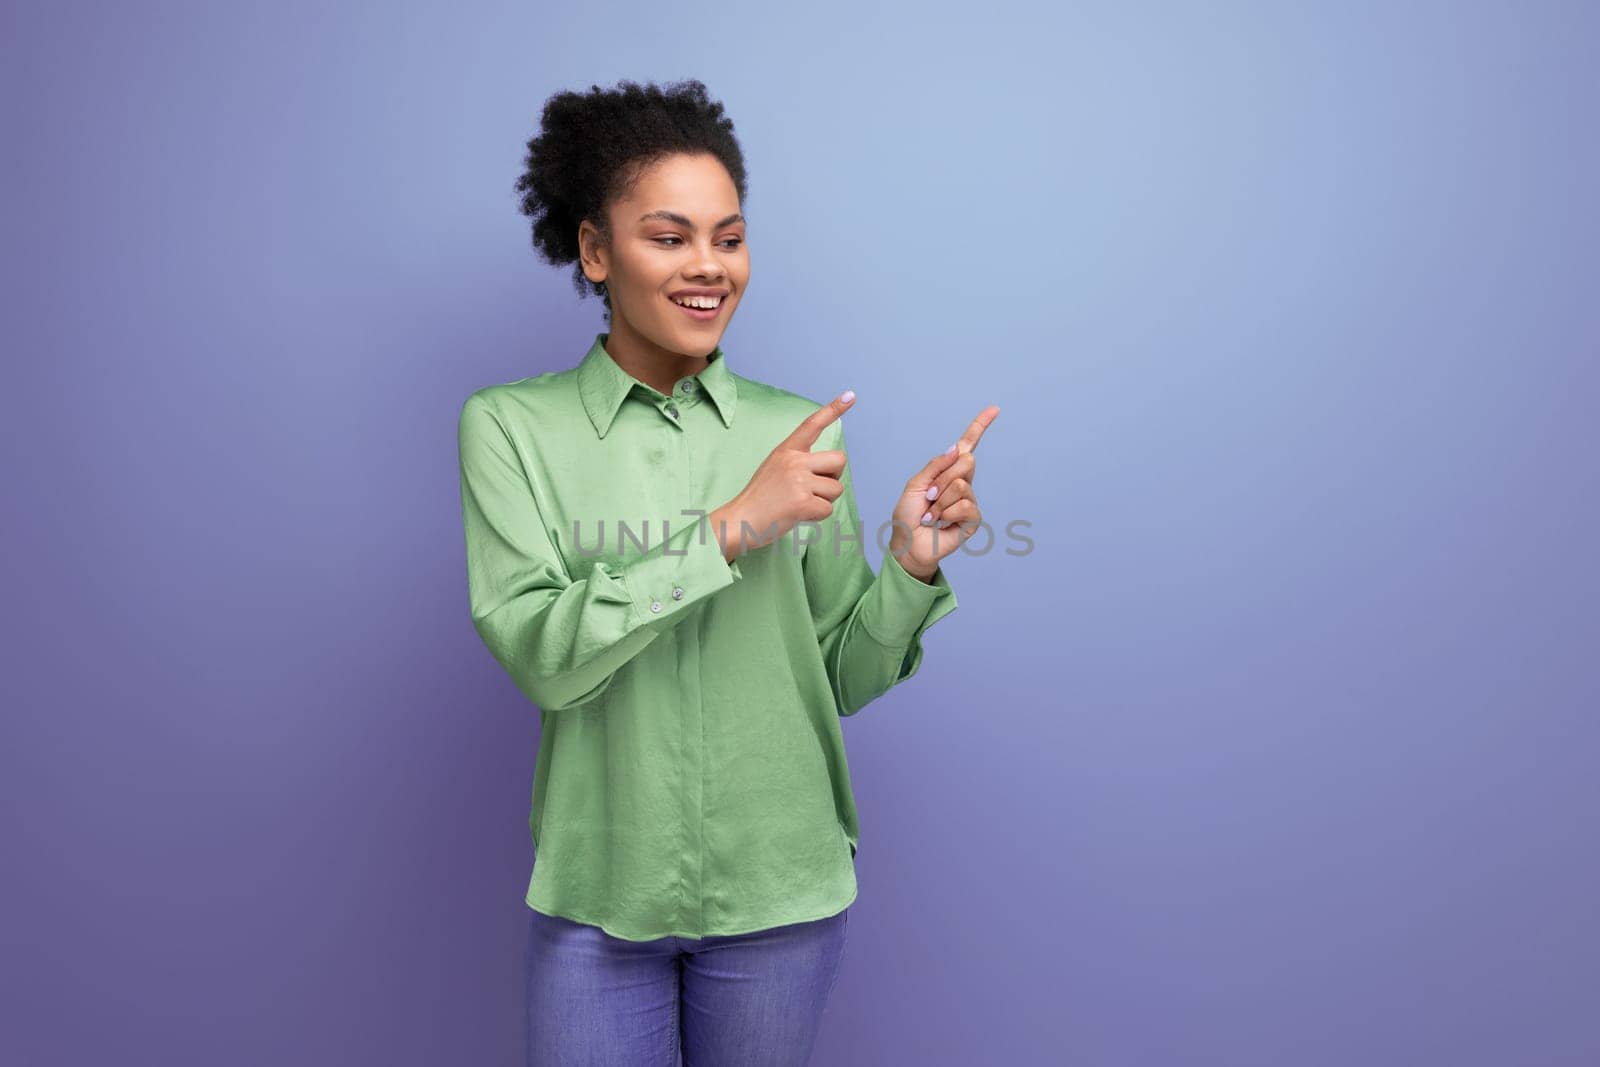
[710,389,856,561]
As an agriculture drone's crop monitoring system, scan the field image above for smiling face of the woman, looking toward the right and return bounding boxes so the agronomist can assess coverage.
[579,154,750,357]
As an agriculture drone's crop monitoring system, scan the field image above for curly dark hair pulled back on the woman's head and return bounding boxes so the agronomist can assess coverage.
[517,80,746,320]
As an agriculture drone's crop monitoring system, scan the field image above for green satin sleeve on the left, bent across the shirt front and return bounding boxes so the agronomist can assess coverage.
[458,394,742,710]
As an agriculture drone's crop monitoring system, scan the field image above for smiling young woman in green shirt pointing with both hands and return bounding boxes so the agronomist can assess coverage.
[459,82,998,1067]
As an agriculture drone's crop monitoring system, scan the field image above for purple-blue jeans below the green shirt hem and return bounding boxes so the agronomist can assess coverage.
[523,907,850,1067]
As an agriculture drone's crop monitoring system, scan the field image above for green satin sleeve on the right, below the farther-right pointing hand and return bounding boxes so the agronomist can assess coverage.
[802,422,957,715]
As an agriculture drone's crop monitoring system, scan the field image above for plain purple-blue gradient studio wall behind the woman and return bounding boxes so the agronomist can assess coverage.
[0,3,1600,1067]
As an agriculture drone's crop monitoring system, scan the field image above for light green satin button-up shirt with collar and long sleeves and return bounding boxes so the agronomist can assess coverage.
[459,333,955,941]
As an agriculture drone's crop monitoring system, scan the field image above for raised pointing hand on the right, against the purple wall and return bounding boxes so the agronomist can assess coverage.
[890,406,1000,582]
